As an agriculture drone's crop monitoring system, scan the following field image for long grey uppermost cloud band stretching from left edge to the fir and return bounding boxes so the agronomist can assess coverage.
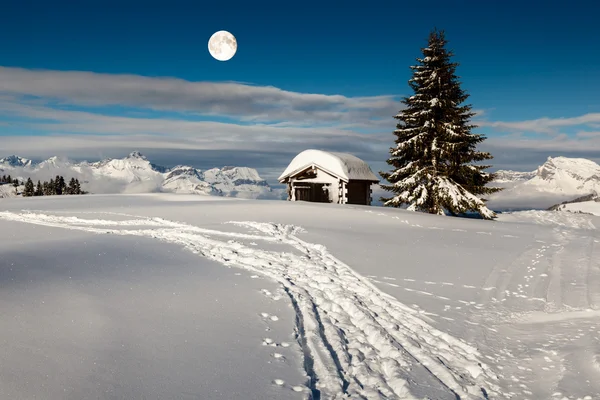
[0,67,400,123]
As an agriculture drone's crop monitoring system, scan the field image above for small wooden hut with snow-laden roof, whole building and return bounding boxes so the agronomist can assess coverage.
[279,150,379,205]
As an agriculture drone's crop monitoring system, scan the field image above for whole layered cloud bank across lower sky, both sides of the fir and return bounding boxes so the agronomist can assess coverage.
[0,67,600,176]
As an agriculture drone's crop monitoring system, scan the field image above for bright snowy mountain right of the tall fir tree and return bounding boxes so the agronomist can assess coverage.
[488,157,600,210]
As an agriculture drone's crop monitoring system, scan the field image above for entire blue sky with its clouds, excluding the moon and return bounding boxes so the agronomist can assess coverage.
[0,0,600,180]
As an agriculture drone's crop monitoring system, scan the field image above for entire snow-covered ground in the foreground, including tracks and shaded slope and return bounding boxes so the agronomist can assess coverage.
[0,192,600,400]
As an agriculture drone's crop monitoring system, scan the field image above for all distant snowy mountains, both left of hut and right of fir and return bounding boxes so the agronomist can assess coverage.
[0,151,600,211]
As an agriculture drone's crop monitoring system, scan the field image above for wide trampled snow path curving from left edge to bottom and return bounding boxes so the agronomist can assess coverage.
[0,212,499,399]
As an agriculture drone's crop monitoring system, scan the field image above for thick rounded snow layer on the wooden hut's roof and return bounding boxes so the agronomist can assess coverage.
[279,150,379,182]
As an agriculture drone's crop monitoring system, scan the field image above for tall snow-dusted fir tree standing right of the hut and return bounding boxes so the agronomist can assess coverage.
[380,30,500,219]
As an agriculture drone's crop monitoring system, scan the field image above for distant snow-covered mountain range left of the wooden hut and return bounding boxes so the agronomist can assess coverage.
[0,151,281,199]
